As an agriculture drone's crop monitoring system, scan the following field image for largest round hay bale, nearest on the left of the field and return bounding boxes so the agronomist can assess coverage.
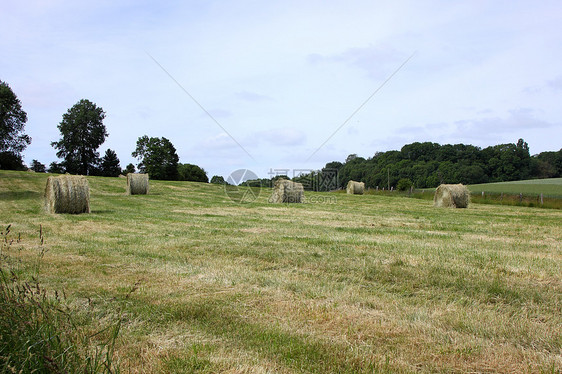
[45,175,90,214]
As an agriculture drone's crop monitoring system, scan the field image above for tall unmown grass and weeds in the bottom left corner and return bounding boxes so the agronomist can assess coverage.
[0,226,120,373]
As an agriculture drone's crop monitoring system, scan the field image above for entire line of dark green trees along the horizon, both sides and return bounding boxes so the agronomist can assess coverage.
[0,80,562,191]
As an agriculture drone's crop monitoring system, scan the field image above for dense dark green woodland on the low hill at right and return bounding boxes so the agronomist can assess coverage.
[300,139,552,189]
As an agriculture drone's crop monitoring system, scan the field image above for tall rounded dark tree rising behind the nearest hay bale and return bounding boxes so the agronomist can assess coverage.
[51,99,108,175]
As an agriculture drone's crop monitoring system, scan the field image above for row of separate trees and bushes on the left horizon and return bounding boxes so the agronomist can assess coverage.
[0,80,209,183]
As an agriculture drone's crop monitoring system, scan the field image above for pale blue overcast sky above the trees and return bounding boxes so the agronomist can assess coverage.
[0,0,562,178]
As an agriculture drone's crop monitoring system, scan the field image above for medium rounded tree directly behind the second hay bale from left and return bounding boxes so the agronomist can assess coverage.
[132,135,179,180]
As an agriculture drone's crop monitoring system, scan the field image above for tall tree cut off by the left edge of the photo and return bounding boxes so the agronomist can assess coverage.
[0,81,31,158]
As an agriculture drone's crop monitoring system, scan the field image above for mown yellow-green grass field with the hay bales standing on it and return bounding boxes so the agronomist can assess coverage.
[0,171,562,373]
